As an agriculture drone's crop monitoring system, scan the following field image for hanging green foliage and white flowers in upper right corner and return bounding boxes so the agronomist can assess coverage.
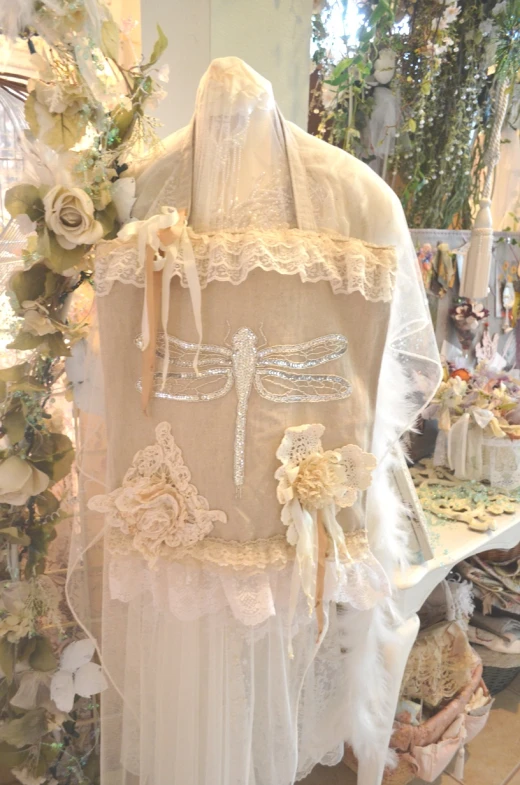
[311,0,520,231]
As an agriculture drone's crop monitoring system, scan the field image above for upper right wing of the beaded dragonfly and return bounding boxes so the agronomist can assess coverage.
[257,334,348,370]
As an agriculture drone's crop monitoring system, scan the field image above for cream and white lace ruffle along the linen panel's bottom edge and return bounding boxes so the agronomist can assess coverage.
[108,529,388,626]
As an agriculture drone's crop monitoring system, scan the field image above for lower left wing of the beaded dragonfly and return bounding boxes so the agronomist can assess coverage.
[137,368,233,401]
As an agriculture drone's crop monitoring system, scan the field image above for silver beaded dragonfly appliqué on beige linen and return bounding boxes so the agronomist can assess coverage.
[137,327,352,493]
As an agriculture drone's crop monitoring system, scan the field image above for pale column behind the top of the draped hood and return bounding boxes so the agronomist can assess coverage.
[141,0,312,136]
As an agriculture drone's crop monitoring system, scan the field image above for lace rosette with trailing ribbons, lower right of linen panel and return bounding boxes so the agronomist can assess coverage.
[275,424,390,632]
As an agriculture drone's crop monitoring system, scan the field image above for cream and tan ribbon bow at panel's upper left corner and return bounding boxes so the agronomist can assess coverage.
[118,207,202,409]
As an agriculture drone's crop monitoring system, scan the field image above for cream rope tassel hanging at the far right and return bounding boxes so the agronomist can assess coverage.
[459,81,509,300]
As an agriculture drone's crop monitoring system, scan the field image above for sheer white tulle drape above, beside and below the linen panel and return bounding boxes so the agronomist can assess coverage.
[68,58,440,785]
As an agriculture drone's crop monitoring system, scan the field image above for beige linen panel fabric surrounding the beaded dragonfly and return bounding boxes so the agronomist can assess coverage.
[97,270,390,541]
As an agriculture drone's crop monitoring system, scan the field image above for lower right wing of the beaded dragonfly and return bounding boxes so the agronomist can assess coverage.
[255,368,352,403]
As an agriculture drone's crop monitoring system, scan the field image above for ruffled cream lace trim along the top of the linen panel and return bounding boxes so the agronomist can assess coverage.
[95,229,397,302]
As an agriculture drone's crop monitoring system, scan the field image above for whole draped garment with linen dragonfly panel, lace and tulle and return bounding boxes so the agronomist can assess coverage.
[67,58,440,785]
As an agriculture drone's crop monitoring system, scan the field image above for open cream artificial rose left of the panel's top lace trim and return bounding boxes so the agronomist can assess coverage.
[43,185,103,250]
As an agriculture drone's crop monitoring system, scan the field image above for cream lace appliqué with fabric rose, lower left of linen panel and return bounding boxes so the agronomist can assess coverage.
[89,422,227,566]
